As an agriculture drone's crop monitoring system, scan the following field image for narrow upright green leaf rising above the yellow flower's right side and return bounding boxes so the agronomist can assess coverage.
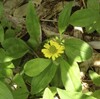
[58,2,73,34]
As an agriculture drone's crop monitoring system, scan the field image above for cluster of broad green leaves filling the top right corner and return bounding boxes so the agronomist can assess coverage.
[69,0,100,33]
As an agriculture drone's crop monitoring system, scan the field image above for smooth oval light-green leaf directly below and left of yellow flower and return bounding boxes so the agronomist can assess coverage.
[24,58,51,77]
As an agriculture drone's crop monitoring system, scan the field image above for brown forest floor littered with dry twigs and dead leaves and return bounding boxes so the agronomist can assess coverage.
[4,0,100,94]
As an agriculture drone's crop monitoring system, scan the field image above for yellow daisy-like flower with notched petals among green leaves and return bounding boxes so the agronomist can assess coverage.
[42,40,65,60]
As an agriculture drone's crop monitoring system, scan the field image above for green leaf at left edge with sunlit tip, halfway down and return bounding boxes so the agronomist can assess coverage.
[0,48,12,63]
